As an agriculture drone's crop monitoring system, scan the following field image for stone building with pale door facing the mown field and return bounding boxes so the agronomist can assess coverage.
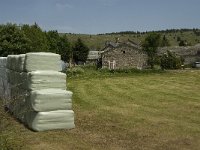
[100,41,147,69]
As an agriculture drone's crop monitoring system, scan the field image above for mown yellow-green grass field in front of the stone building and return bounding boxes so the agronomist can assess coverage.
[0,70,200,150]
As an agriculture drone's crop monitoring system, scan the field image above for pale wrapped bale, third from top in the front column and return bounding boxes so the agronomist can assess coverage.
[26,89,72,112]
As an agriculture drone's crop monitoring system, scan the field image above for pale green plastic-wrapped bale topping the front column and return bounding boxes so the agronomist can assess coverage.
[24,52,62,72]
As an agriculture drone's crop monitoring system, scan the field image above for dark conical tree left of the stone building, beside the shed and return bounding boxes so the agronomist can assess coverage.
[73,38,89,63]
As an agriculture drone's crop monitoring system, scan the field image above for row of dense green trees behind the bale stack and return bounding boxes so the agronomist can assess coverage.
[0,23,89,62]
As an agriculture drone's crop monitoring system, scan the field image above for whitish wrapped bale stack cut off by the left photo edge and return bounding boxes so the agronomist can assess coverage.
[0,57,8,100]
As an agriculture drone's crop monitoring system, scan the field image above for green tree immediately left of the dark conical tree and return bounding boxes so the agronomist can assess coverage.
[58,35,72,62]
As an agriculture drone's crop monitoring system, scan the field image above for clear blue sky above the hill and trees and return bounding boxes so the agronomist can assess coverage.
[0,0,200,34]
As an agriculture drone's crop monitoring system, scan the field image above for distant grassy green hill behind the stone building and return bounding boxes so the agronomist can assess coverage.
[60,29,200,50]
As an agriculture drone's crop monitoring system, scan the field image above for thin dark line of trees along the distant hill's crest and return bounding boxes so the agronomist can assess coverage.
[98,28,200,36]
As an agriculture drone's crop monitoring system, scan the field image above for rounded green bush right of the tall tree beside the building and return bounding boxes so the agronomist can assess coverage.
[161,51,184,69]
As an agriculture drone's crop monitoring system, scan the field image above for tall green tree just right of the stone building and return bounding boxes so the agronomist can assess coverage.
[142,32,160,69]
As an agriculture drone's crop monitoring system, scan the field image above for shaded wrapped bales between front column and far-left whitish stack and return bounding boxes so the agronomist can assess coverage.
[6,54,27,122]
